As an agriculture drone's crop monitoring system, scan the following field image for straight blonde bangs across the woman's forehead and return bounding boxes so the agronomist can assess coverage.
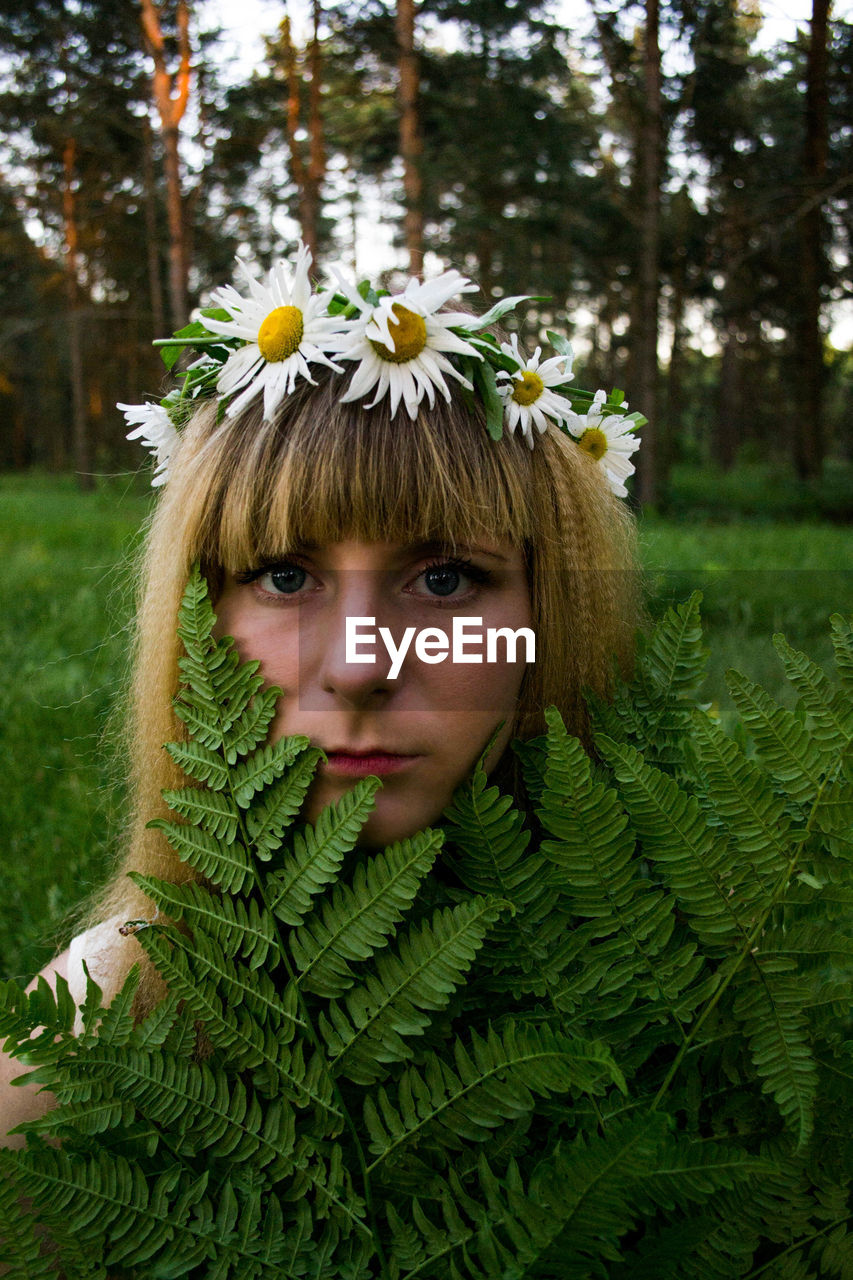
[181,373,537,572]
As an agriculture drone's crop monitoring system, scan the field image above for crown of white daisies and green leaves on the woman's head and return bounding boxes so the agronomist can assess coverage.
[118,244,646,498]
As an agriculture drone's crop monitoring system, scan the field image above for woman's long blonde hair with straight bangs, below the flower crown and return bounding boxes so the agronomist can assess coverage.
[92,366,638,1003]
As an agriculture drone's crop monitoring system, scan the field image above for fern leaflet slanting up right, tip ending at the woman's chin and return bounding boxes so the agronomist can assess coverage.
[289,829,444,997]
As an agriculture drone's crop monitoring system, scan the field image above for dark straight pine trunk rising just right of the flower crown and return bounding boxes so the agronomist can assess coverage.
[630,0,663,504]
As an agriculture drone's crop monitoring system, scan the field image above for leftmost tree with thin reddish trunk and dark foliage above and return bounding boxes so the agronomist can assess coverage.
[0,0,149,488]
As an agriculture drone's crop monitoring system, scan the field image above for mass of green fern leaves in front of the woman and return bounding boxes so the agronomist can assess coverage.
[0,570,853,1280]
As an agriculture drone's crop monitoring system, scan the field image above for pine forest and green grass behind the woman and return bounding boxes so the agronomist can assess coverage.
[0,0,853,975]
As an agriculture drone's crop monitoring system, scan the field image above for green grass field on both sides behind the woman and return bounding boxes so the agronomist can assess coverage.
[0,476,853,977]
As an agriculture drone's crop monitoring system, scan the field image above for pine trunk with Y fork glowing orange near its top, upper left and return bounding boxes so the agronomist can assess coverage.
[141,0,190,329]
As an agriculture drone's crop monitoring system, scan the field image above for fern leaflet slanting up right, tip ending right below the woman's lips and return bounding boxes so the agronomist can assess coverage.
[265,778,380,927]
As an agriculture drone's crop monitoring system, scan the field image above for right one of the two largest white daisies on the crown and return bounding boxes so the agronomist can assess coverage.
[326,271,483,419]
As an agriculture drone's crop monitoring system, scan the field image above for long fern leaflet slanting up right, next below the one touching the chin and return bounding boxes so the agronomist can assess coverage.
[319,897,507,1084]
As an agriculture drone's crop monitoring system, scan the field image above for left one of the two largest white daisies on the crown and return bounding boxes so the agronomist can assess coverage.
[204,243,343,421]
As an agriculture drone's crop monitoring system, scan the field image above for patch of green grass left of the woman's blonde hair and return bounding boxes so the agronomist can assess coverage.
[0,476,147,977]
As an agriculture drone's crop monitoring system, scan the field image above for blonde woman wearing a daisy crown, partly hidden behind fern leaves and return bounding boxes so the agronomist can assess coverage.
[0,250,638,1143]
